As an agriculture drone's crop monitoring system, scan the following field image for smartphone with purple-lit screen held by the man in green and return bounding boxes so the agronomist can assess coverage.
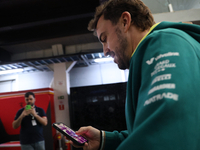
[52,122,87,146]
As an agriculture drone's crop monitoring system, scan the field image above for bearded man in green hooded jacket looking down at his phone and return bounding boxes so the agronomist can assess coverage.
[68,0,200,150]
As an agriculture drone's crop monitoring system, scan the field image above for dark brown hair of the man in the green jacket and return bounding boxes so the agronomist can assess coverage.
[88,0,155,31]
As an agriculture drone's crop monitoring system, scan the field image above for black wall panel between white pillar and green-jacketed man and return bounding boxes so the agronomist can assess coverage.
[69,82,126,150]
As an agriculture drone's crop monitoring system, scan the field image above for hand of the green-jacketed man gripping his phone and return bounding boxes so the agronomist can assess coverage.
[70,126,101,150]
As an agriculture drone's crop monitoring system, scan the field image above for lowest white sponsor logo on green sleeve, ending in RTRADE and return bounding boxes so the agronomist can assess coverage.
[144,92,179,106]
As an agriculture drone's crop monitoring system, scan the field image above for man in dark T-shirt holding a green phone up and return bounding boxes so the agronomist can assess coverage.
[12,92,47,150]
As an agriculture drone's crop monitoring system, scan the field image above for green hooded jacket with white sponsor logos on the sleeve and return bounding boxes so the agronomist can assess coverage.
[104,22,200,150]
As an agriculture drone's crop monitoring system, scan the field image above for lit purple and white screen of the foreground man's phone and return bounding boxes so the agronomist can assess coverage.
[55,123,87,143]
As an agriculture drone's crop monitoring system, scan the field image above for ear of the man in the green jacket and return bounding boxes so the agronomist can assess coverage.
[121,11,131,32]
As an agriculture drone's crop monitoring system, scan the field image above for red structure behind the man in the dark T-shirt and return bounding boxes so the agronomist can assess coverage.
[0,88,56,150]
